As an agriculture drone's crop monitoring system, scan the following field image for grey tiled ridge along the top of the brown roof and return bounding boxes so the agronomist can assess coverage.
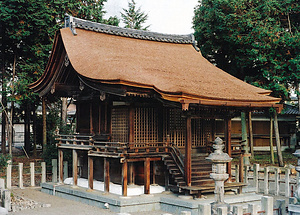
[65,14,196,46]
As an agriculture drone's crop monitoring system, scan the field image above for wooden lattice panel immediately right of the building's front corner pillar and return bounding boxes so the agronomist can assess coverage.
[134,108,158,143]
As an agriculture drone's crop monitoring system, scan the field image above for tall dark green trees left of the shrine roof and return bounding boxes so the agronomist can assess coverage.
[0,0,119,155]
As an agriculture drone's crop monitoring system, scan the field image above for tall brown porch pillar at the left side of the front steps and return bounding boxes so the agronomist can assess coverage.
[184,116,192,186]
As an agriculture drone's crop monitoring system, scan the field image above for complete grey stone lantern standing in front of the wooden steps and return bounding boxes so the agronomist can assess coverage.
[206,137,232,214]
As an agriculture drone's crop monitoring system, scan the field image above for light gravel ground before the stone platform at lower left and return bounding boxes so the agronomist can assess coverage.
[9,188,167,215]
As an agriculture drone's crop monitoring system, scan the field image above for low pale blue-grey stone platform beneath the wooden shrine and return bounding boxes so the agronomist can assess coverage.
[41,183,262,215]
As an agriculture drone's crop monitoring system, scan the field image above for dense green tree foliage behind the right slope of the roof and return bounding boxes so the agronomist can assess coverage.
[193,0,300,99]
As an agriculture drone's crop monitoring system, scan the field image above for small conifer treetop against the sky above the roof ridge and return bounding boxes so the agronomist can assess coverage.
[121,0,150,30]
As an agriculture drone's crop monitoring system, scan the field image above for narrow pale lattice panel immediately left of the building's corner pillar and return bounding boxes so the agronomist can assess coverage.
[111,107,129,142]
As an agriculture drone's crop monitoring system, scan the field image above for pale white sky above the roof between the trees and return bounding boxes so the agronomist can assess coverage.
[104,0,198,34]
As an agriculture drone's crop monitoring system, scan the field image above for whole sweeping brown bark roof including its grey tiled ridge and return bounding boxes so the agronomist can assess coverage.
[31,15,280,107]
